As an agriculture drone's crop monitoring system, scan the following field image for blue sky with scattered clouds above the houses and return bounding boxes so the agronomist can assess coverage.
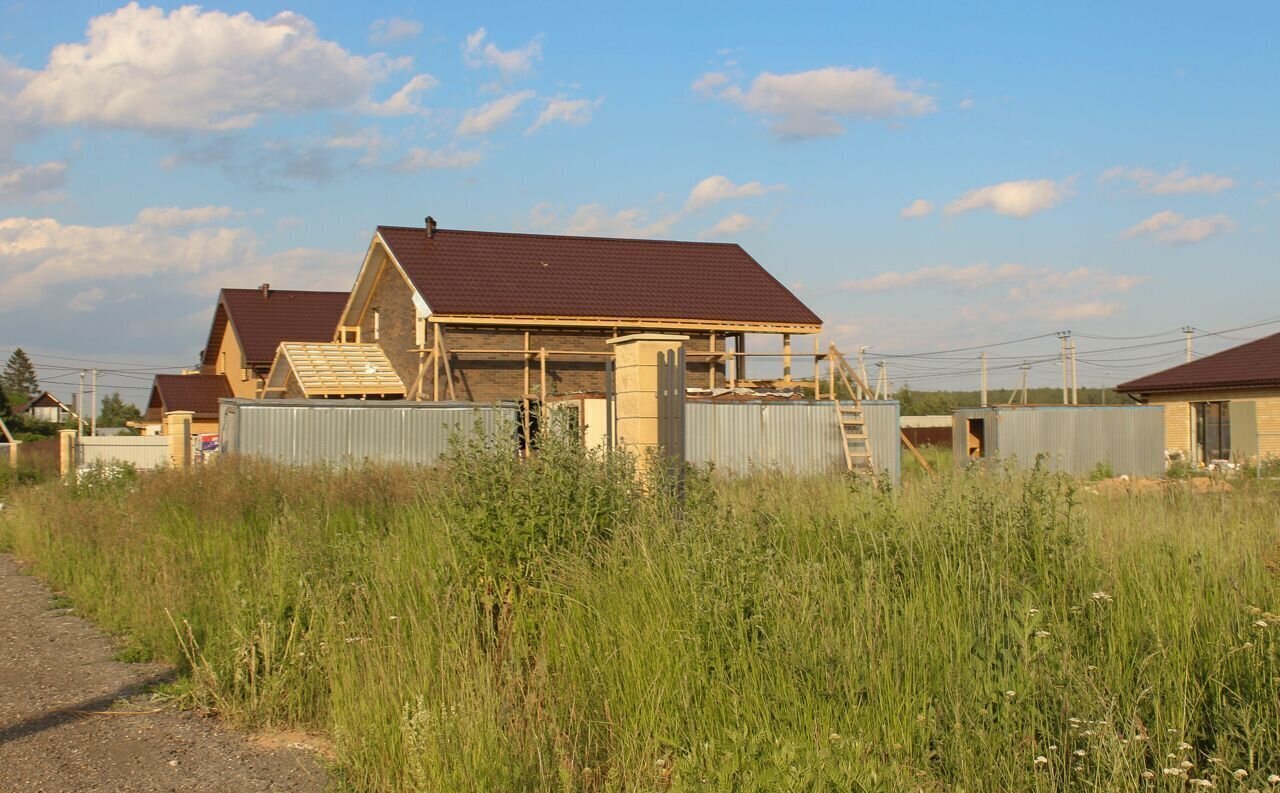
[0,0,1280,402]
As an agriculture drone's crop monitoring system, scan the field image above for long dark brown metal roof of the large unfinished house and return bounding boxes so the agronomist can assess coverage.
[378,226,822,325]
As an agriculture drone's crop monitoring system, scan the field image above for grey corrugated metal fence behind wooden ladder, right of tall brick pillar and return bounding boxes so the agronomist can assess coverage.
[685,400,902,485]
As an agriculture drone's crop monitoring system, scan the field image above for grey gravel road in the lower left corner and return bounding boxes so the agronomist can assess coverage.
[0,554,326,793]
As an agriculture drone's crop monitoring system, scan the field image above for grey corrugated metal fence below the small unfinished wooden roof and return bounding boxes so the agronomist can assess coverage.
[219,399,517,466]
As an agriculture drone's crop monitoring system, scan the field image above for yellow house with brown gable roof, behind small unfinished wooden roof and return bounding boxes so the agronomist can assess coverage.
[200,284,348,399]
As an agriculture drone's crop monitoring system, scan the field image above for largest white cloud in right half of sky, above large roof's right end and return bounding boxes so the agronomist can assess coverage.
[692,67,937,138]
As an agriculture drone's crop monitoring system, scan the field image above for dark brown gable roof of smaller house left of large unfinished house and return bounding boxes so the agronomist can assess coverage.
[204,289,348,367]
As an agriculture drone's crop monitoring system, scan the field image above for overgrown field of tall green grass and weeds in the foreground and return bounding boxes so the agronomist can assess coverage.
[0,444,1280,792]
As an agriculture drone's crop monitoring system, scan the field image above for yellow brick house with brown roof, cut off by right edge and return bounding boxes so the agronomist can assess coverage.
[1116,334,1280,464]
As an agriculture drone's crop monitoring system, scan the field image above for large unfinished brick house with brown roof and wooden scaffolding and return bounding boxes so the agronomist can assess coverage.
[276,217,822,402]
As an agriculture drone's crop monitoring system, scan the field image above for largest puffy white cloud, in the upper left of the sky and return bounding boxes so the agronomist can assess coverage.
[18,3,408,130]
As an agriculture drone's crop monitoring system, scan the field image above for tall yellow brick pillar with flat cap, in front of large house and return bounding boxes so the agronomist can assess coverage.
[607,333,689,473]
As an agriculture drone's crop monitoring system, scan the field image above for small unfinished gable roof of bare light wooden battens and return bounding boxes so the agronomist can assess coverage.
[266,342,404,397]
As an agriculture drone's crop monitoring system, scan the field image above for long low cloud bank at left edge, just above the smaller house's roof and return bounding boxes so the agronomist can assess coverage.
[0,212,353,310]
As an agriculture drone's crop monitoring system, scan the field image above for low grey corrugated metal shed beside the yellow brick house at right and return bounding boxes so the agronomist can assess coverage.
[952,405,1165,477]
